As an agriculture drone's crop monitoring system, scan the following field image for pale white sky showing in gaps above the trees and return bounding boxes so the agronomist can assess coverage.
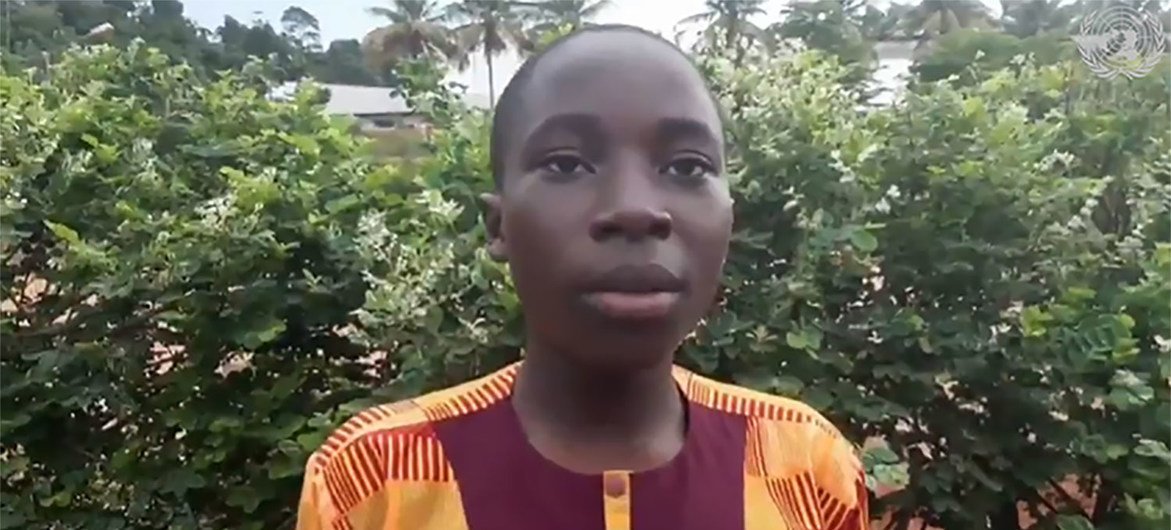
[184,0,1000,95]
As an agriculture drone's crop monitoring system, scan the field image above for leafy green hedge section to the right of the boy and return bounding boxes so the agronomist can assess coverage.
[690,47,1171,529]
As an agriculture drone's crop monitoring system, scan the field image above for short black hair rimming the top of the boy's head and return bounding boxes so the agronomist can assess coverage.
[488,23,724,192]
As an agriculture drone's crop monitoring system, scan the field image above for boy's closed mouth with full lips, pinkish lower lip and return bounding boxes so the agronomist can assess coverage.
[584,264,686,319]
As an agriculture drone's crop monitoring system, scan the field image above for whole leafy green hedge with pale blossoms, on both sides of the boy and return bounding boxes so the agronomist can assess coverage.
[0,46,1171,530]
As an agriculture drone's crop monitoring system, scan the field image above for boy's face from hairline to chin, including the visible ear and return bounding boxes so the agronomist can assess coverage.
[487,33,732,370]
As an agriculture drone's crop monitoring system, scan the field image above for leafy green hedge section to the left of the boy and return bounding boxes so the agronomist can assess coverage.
[0,46,475,529]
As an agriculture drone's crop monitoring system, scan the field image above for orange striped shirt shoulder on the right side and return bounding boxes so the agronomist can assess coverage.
[678,371,865,507]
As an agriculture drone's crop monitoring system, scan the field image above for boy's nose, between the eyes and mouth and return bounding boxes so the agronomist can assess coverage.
[590,166,672,241]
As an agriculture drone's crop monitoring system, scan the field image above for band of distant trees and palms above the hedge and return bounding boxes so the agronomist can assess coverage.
[0,0,1171,101]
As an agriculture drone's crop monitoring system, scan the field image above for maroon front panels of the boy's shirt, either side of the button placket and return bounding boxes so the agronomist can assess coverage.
[434,399,746,530]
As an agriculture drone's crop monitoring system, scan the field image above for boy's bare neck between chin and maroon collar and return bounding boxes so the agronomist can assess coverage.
[513,343,684,440]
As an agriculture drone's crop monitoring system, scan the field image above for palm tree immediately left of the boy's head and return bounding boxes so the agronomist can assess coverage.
[448,0,529,109]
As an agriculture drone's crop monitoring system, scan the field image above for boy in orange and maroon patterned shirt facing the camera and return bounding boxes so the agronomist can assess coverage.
[297,26,869,530]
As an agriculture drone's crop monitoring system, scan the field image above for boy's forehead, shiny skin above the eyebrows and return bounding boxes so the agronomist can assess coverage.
[516,32,720,136]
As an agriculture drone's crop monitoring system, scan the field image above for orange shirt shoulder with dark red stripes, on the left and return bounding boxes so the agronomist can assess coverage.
[306,366,515,512]
